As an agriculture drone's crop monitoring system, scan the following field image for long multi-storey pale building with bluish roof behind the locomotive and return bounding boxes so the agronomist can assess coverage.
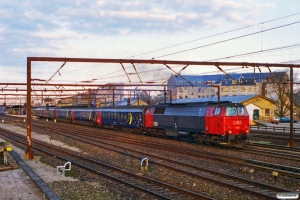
[167,72,288,99]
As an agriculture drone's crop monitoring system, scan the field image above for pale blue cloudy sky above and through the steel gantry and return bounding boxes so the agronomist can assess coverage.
[0,0,300,83]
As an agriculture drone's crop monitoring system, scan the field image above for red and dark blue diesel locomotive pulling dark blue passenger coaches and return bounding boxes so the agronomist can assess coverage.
[32,101,251,147]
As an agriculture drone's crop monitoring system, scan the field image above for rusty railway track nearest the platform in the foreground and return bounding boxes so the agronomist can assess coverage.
[0,128,214,199]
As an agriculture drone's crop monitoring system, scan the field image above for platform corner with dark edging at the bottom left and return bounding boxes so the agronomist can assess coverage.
[0,151,59,200]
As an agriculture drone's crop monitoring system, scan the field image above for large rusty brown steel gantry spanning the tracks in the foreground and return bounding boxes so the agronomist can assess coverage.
[25,57,300,159]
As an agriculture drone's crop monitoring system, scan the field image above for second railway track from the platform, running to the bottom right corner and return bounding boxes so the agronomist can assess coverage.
[19,122,298,198]
